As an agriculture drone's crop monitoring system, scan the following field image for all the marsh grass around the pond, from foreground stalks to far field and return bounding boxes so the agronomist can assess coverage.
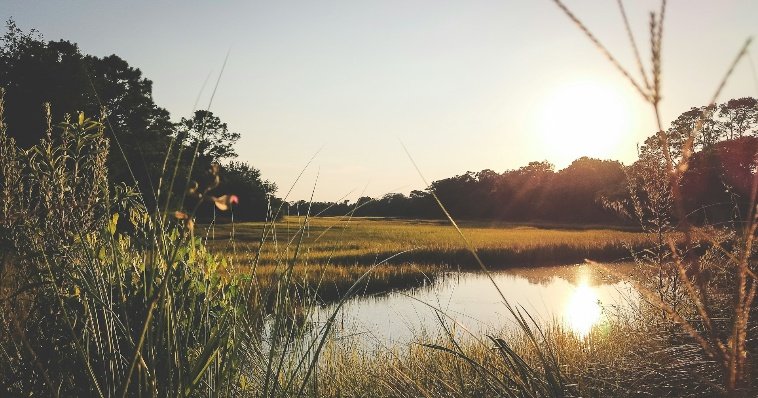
[0,0,758,397]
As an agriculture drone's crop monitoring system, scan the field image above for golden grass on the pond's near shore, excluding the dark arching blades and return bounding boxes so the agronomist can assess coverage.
[314,319,717,397]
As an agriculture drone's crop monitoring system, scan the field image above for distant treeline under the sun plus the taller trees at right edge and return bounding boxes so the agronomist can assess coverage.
[300,98,758,225]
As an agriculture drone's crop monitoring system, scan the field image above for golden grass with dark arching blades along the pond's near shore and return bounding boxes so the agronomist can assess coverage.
[314,288,744,397]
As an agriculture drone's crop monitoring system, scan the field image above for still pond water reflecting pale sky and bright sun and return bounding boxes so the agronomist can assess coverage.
[314,265,639,346]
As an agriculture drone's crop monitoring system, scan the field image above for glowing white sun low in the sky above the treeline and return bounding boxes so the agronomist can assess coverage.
[537,81,631,166]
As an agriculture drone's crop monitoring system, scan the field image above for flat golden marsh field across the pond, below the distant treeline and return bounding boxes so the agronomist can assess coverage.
[202,216,655,301]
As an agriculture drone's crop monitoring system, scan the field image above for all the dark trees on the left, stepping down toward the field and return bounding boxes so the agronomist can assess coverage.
[0,20,276,220]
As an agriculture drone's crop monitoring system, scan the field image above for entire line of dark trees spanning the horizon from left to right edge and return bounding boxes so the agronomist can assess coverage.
[0,20,758,224]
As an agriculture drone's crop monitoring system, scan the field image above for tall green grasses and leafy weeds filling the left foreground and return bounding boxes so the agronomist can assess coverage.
[0,88,400,397]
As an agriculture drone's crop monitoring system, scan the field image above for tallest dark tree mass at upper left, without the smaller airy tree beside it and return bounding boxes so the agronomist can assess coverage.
[0,20,173,198]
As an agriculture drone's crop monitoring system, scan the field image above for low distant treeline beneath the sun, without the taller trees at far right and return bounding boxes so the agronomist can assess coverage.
[290,157,626,224]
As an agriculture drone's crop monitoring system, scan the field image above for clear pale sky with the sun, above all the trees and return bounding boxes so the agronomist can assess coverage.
[0,0,758,200]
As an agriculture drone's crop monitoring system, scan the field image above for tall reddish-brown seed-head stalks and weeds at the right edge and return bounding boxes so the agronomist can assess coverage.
[554,0,758,396]
